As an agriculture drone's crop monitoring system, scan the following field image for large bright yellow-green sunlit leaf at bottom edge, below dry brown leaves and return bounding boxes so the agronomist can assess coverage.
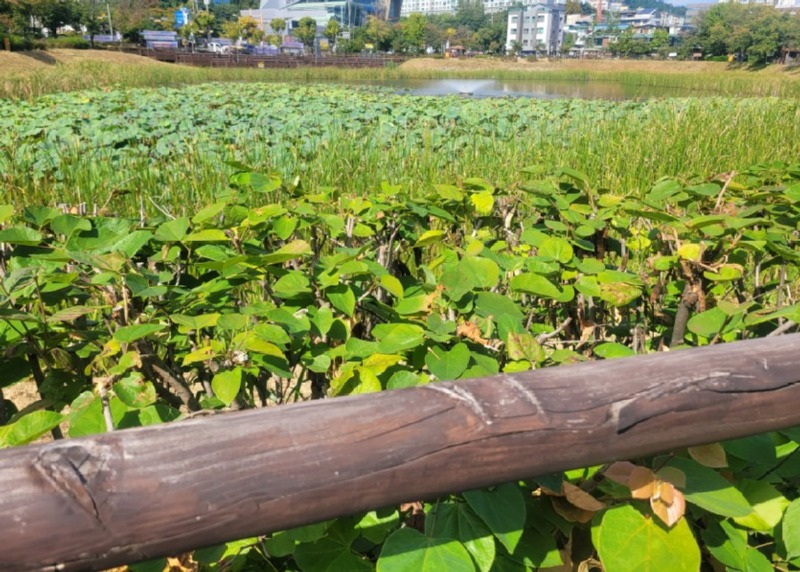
[592,505,700,572]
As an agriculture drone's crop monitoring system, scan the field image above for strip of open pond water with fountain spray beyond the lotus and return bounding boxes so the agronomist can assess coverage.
[322,79,696,99]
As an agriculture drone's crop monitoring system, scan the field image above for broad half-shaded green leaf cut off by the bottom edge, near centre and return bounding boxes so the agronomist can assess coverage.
[376,528,475,572]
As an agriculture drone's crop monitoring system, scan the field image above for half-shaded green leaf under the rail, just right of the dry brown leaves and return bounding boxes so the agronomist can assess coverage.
[668,457,753,517]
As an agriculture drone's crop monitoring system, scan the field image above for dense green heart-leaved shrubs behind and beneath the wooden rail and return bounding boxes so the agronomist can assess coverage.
[0,159,800,572]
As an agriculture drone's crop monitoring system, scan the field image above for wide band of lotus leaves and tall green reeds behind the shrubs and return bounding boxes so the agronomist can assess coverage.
[0,84,800,214]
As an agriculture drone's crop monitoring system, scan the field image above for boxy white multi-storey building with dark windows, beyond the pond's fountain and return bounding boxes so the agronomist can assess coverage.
[506,3,566,54]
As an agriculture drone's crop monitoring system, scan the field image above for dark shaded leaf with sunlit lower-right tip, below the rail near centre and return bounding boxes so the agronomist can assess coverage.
[425,502,495,572]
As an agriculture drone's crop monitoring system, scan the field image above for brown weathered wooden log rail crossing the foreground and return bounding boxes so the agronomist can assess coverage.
[0,334,800,571]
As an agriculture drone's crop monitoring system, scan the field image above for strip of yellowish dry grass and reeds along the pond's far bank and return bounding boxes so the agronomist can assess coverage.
[0,50,800,98]
